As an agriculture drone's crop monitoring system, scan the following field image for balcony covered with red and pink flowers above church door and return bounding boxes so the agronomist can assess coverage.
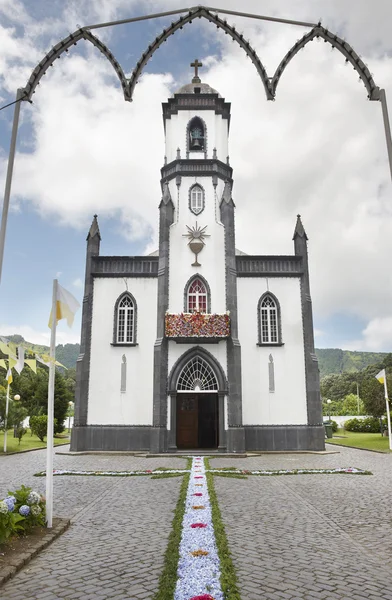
[165,312,230,343]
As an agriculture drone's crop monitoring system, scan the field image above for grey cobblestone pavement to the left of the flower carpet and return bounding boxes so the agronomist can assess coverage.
[0,450,185,600]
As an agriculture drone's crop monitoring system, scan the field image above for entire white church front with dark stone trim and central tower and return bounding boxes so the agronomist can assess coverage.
[71,68,325,453]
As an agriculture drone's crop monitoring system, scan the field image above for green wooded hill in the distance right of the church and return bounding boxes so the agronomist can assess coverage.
[316,348,388,378]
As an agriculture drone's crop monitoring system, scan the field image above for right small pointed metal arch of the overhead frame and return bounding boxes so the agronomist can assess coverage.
[271,25,380,100]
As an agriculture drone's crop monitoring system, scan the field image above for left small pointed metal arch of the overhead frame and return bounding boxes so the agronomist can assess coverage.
[23,28,131,102]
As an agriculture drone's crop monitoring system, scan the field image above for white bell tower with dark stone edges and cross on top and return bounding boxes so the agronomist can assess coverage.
[154,59,243,451]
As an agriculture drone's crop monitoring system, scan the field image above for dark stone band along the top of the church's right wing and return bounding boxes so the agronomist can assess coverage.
[236,255,304,277]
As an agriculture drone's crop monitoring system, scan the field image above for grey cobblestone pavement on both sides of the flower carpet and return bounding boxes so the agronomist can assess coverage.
[0,448,392,600]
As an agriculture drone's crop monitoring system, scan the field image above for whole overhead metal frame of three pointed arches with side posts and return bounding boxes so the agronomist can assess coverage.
[0,6,392,282]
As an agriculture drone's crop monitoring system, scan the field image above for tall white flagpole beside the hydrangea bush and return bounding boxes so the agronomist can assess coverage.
[46,279,57,528]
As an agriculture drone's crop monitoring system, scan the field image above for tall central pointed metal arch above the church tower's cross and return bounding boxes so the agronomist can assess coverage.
[129,7,274,100]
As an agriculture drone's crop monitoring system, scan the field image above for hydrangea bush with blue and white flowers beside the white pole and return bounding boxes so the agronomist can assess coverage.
[0,485,45,545]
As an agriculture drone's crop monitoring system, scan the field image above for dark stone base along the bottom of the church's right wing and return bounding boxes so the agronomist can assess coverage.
[244,424,325,452]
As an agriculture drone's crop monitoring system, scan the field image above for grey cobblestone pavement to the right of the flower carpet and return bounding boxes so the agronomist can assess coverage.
[211,446,392,600]
